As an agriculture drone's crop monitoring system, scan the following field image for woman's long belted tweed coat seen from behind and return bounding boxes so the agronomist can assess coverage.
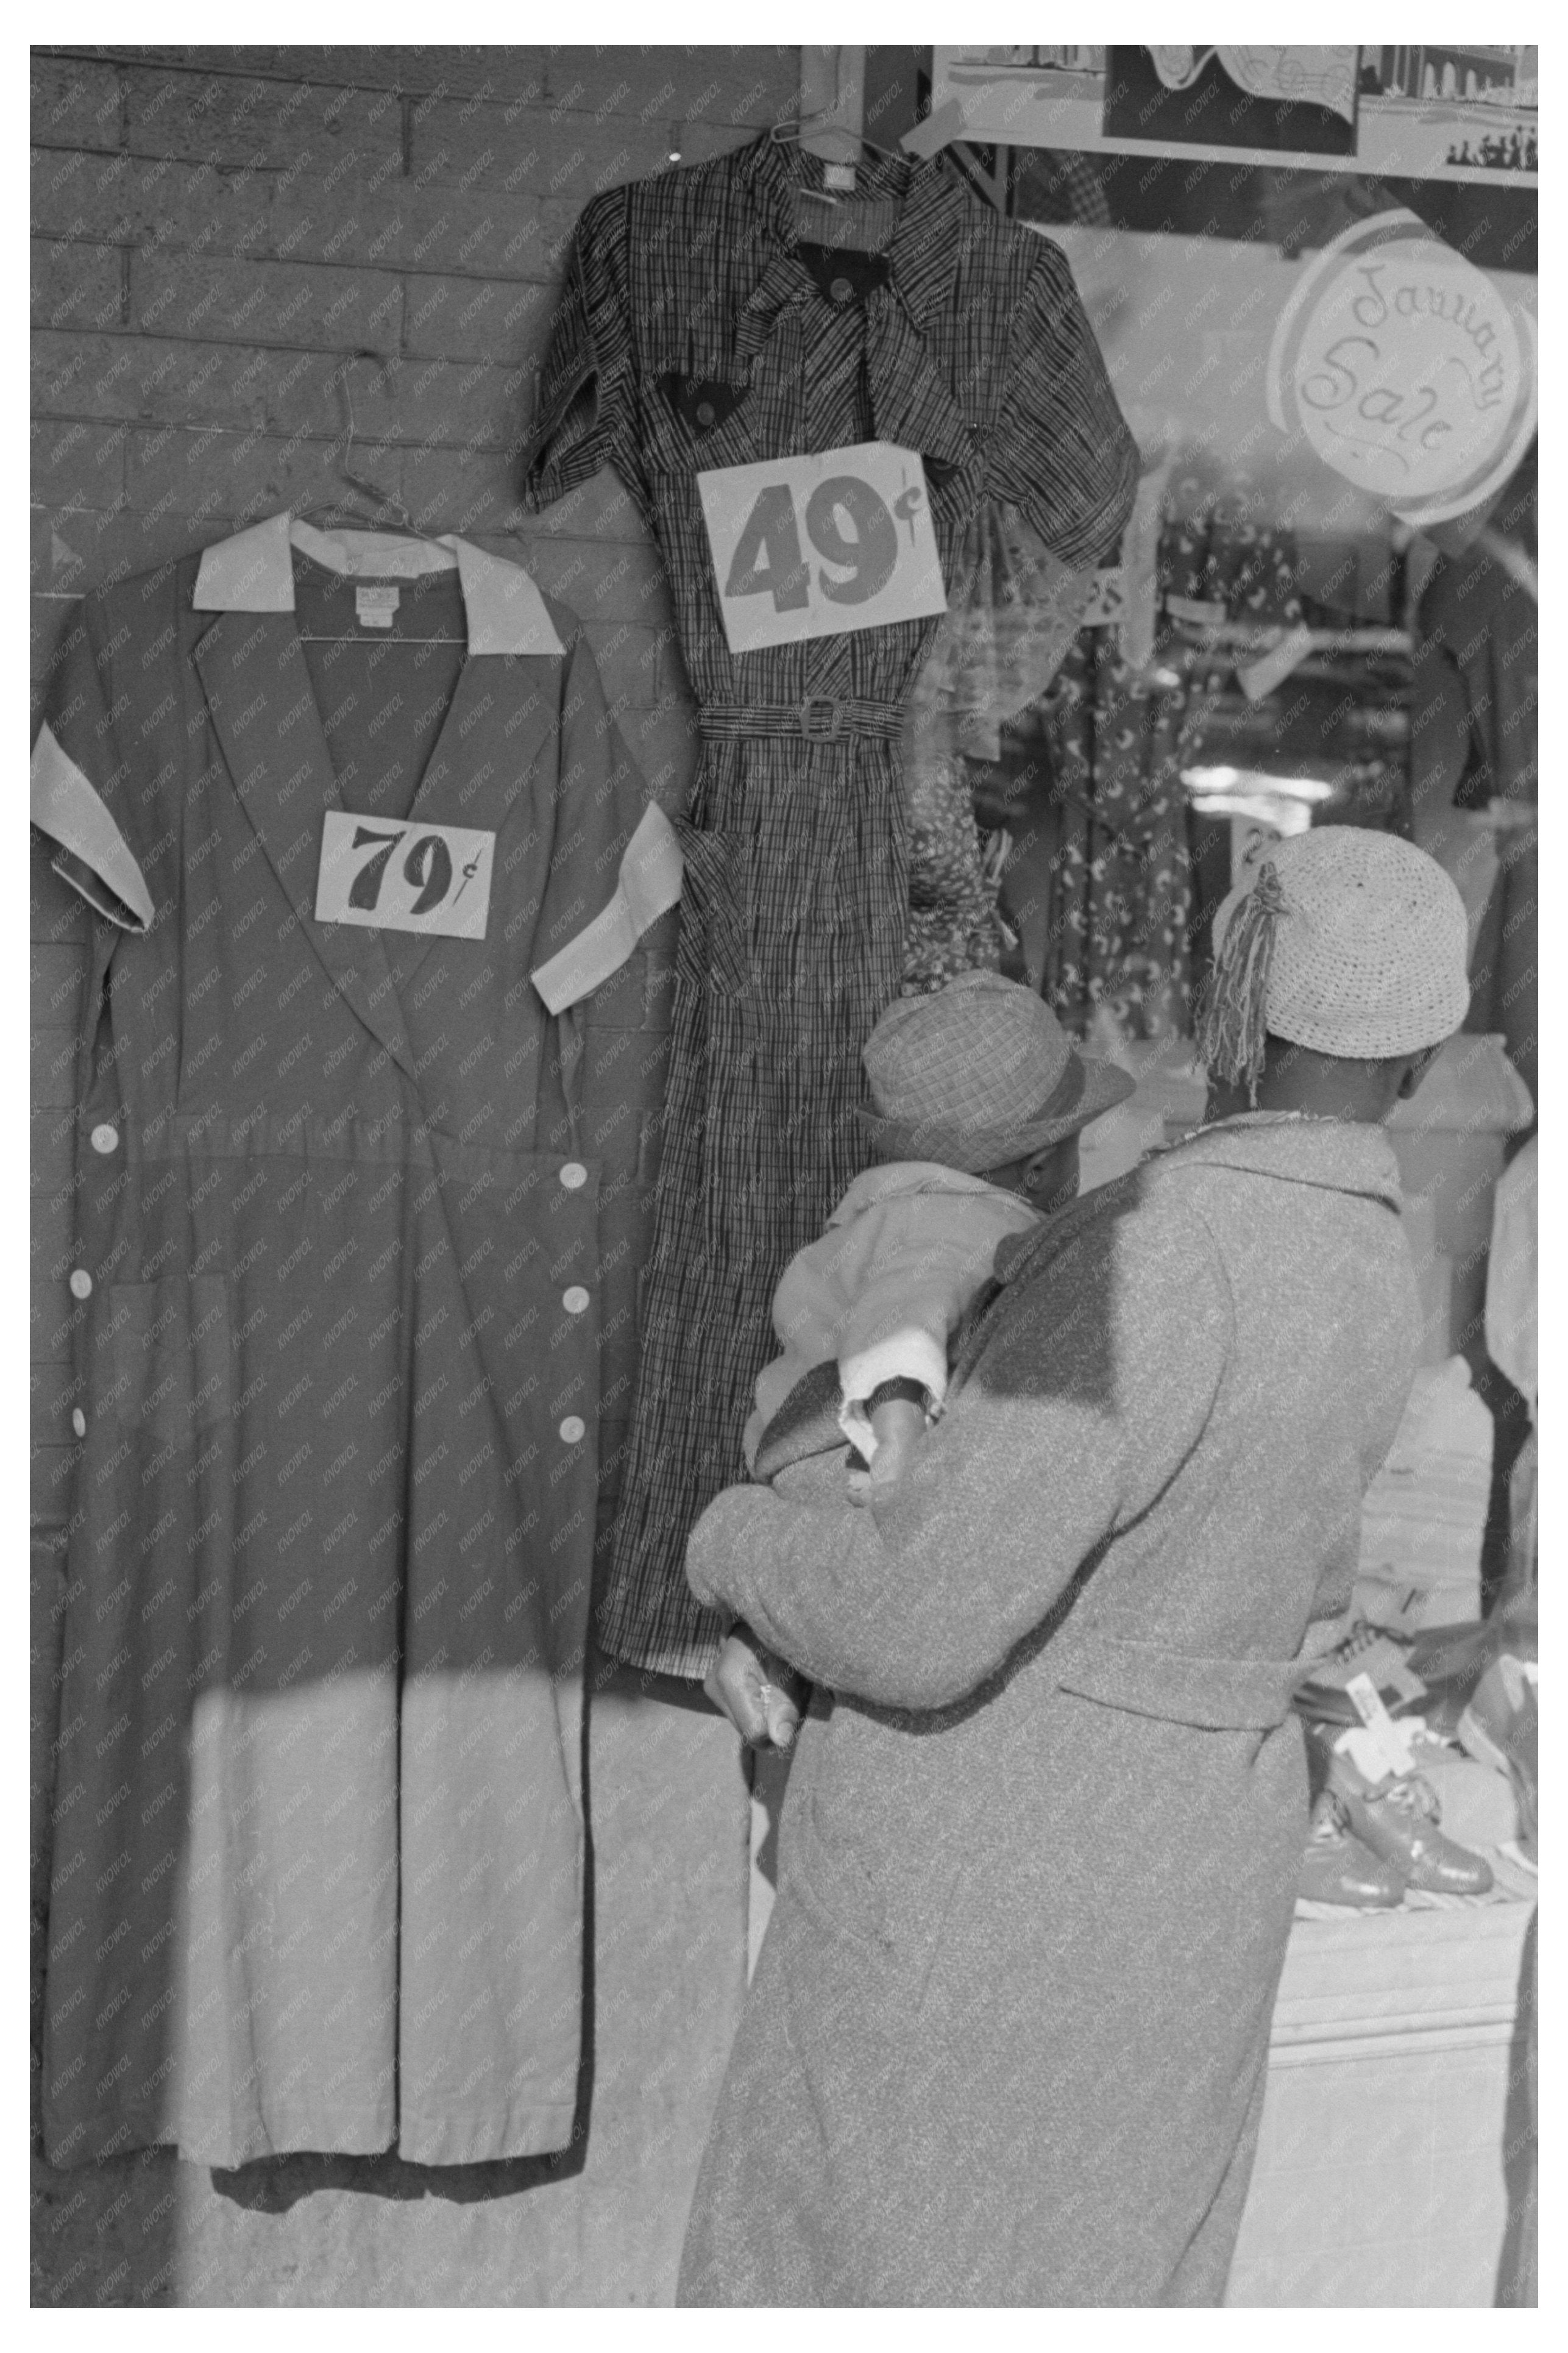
[679,1116,1417,2306]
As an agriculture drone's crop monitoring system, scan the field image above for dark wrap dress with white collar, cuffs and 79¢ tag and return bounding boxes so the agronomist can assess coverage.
[33,515,679,2167]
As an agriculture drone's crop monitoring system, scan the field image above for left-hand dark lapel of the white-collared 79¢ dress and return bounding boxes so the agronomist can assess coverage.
[195,612,420,1078]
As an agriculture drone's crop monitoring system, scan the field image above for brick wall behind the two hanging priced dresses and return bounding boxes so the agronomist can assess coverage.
[30,47,800,1529]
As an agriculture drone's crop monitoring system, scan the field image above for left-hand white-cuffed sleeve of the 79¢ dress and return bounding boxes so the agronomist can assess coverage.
[30,596,157,932]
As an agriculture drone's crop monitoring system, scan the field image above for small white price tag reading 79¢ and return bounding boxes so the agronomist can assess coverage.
[315,810,496,939]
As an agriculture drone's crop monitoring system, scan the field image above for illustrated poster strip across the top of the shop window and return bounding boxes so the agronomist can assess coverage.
[926,42,1538,188]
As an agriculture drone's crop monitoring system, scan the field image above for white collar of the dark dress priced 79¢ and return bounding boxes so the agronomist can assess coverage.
[190,511,564,654]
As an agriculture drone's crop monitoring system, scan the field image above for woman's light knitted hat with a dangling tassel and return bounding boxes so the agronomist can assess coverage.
[1197,826,1469,1099]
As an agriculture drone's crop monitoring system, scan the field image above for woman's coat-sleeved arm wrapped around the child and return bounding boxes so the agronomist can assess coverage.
[686,1209,1230,1708]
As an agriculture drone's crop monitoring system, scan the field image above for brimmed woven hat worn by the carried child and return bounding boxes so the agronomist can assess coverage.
[860,972,1133,1174]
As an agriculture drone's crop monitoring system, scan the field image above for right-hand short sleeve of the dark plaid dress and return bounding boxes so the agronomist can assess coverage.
[985,238,1138,564]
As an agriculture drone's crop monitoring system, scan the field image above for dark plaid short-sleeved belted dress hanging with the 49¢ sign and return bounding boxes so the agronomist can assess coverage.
[527,137,1135,1675]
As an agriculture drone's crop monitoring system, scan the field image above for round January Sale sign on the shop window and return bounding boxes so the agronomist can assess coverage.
[1267,212,1535,525]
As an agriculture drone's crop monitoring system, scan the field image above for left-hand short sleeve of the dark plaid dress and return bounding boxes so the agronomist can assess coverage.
[522,188,642,511]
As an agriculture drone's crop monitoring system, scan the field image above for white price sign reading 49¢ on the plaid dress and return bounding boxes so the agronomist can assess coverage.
[696,443,948,654]
